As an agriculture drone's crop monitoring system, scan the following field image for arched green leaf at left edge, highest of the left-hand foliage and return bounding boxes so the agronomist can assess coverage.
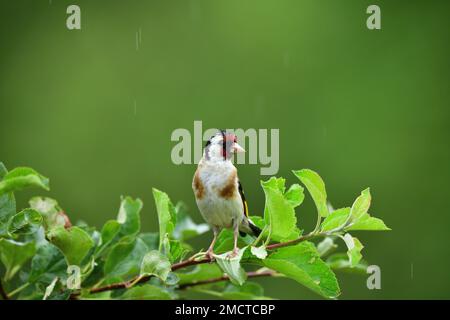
[0,167,50,195]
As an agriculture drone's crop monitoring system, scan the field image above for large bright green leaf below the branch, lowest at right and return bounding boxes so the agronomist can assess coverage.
[261,241,340,298]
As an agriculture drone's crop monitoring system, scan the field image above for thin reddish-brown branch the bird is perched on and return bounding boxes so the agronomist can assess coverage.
[71,233,323,298]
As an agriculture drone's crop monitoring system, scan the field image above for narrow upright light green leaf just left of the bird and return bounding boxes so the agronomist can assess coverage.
[153,188,177,251]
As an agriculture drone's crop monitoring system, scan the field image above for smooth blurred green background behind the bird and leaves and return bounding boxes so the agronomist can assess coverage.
[0,0,450,299]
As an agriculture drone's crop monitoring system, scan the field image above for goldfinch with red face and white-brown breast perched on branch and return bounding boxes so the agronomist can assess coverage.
[192,130,261,259]
